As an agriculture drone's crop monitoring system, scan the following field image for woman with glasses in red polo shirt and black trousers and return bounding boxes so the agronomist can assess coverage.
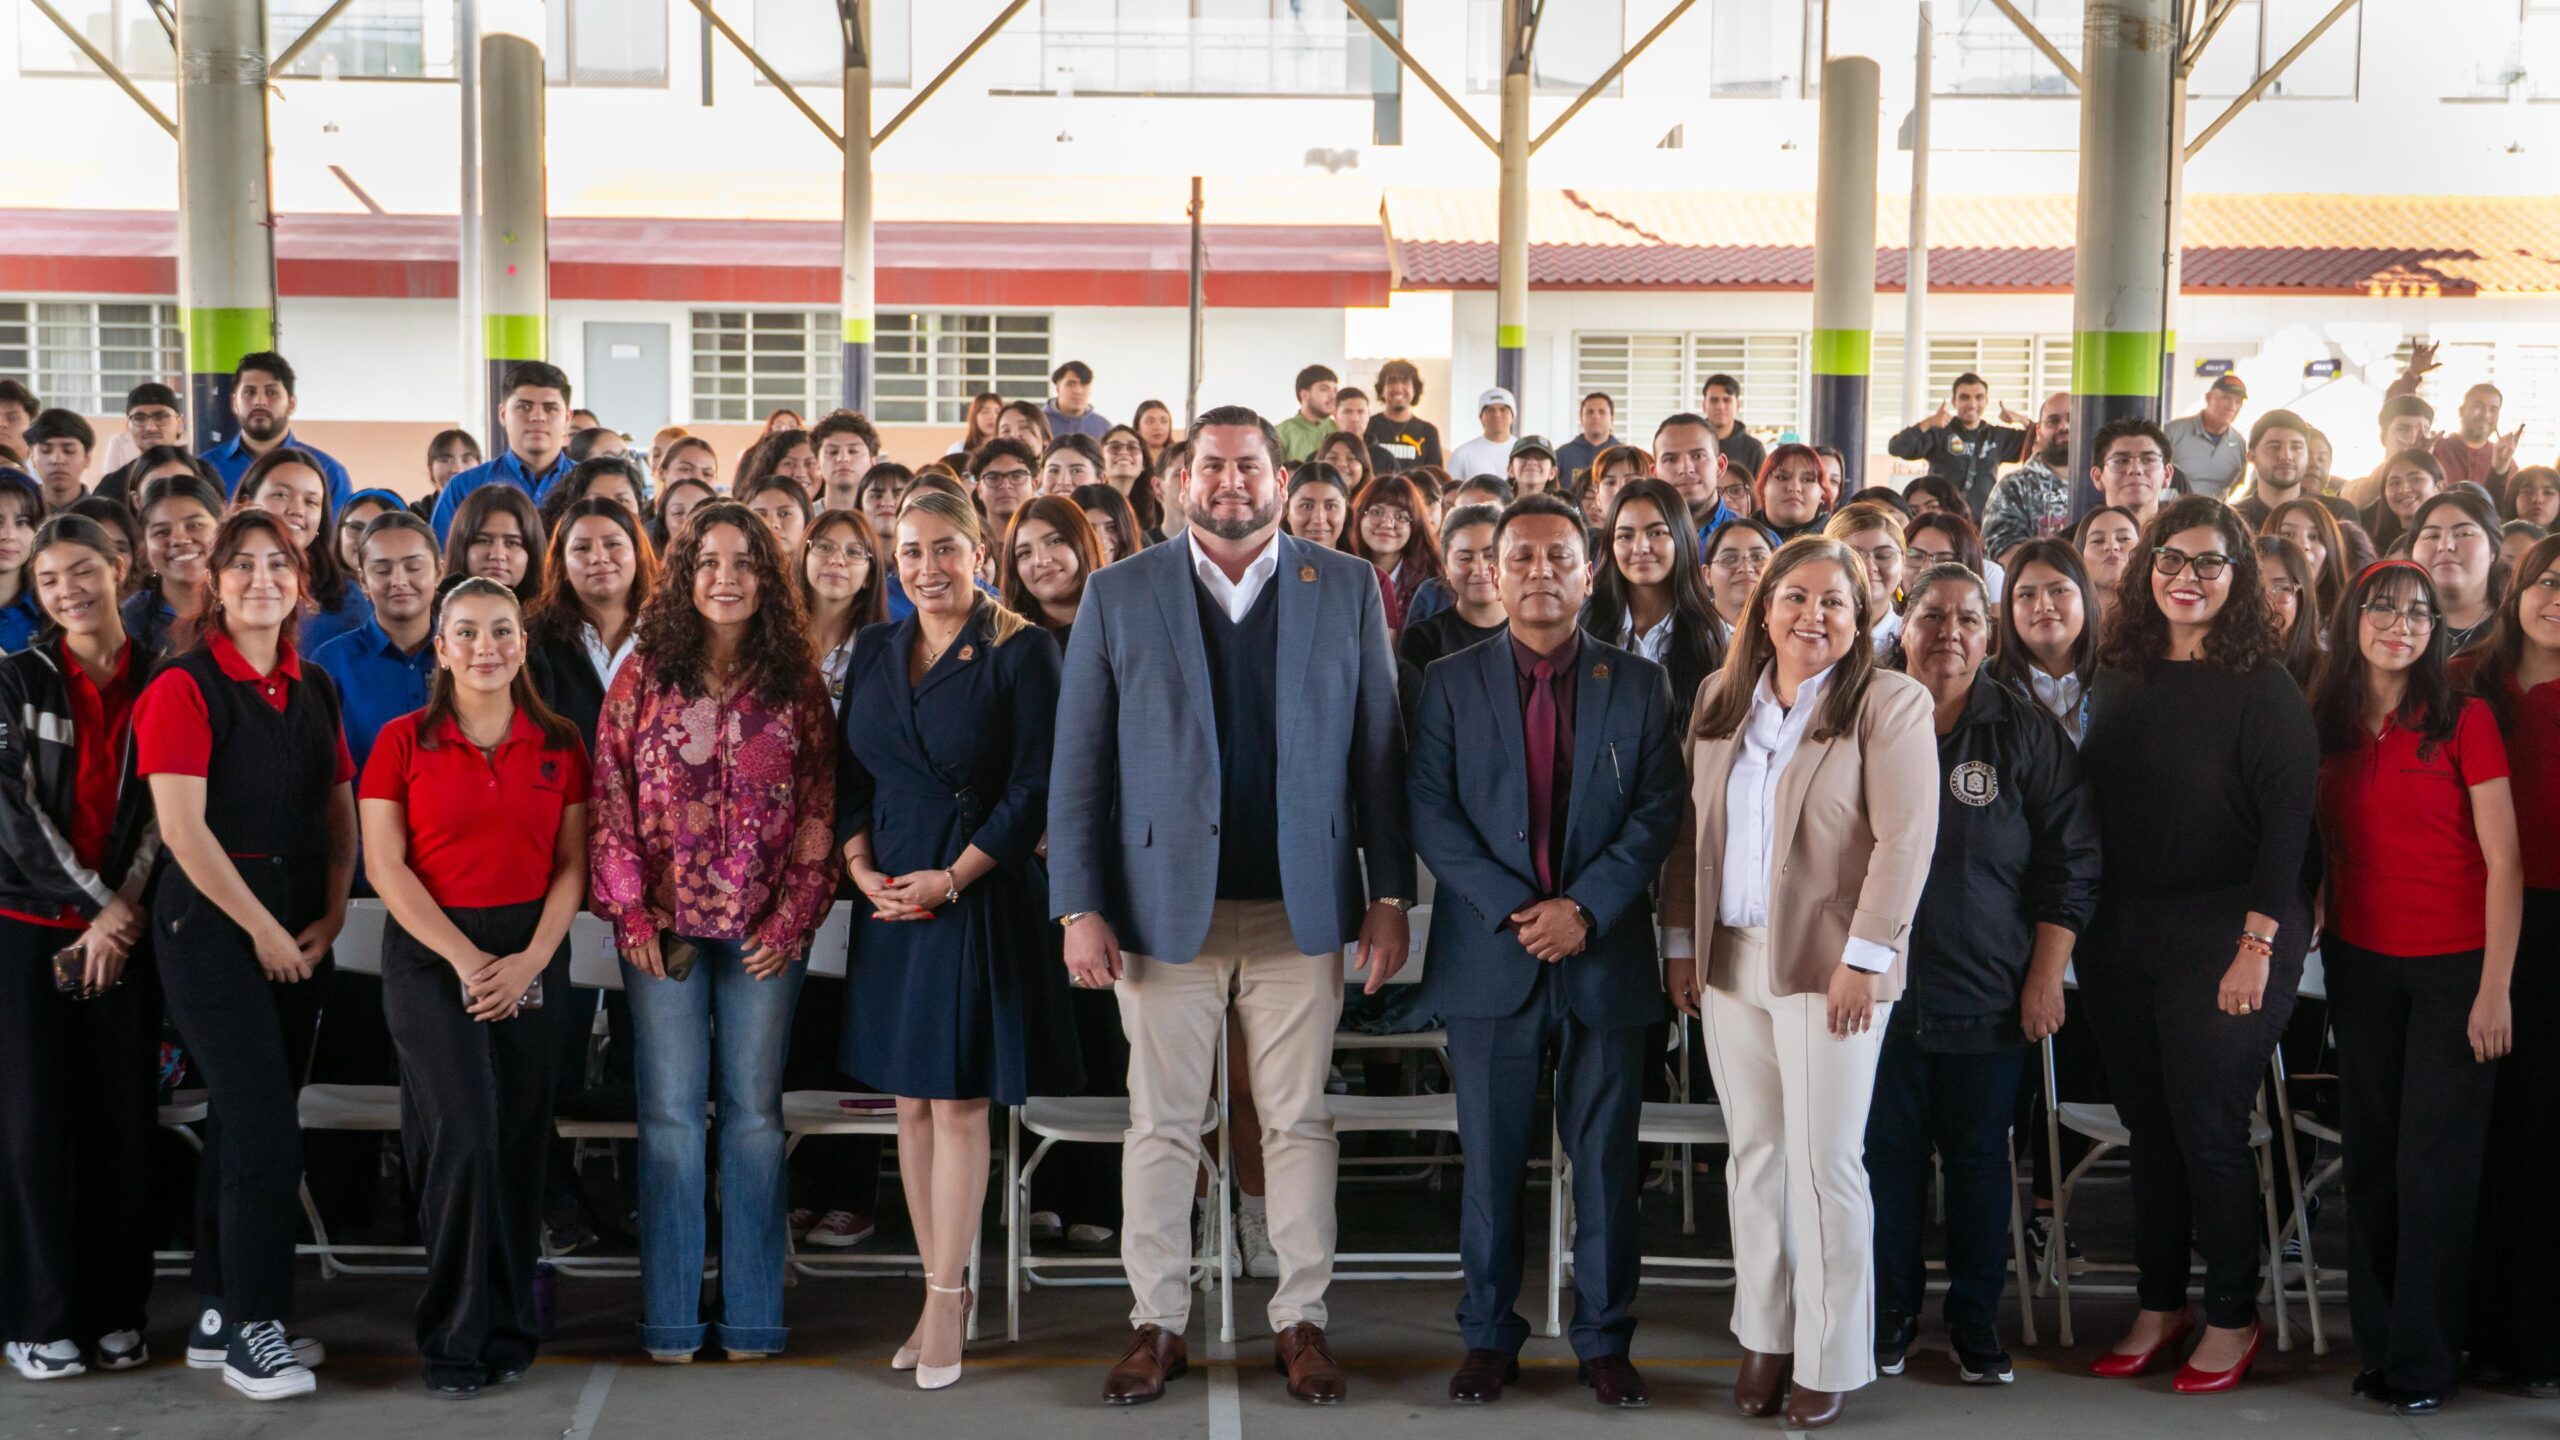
[2312,561,2524,1414]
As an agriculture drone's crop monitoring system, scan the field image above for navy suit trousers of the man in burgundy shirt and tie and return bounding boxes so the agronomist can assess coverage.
[1449,961,1649,1361]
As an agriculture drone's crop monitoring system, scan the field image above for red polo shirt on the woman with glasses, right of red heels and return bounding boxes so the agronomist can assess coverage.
[2319,700,2524,956]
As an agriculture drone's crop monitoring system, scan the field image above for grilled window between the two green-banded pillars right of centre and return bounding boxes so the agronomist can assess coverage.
[1574,331,1805,448]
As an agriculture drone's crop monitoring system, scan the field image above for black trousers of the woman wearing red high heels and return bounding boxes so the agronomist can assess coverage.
[2079,899,2309,1327]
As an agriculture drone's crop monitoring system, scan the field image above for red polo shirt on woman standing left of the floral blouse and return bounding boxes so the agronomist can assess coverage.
[356,710,586,910]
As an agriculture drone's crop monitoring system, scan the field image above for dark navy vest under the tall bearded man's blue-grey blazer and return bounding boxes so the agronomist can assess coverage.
[1190,577,1280,899]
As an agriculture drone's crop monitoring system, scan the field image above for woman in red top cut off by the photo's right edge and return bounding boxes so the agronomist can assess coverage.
[2452,536,2560,1394]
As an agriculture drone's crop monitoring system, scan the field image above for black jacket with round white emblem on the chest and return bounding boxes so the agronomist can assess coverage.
[1892,674,2099,1053]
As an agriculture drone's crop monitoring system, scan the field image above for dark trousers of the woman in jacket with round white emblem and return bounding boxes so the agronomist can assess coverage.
[1866,1010,2028,1330]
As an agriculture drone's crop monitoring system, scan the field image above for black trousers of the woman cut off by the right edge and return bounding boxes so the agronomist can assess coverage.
[2470,889,2560,1381]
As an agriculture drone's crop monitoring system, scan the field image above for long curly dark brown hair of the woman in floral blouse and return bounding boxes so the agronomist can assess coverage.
[635,500,817,707]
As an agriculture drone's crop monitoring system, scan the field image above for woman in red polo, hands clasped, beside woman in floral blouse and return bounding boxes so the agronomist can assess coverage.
[358,579,586,1396]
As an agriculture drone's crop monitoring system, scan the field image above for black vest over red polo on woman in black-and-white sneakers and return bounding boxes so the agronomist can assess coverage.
[169,638,340,858]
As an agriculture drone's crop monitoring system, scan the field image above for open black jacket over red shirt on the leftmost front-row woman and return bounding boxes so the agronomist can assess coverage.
[0,643,161,917]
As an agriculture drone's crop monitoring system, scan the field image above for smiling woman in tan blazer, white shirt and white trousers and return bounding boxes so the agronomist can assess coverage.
[1661,536,1938,1430]
